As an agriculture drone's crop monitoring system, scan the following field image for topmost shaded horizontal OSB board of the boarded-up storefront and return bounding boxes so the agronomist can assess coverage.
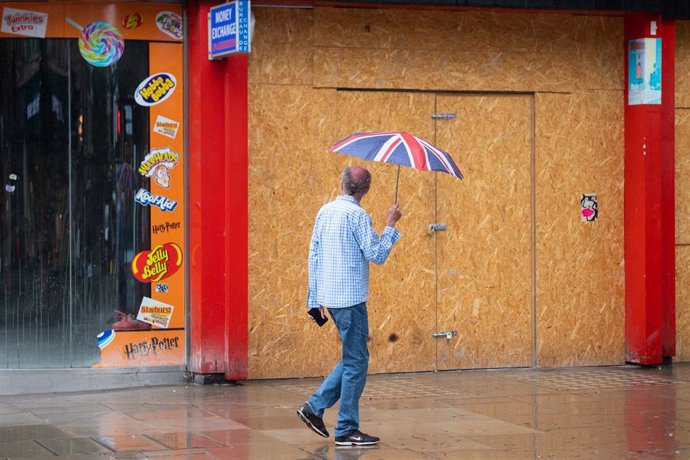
[314,8,623,55]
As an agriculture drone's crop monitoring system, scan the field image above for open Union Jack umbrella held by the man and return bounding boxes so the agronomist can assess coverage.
[330,131,463,203]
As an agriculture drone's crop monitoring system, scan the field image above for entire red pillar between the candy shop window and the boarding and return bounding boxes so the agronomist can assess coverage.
[187,1,248,379]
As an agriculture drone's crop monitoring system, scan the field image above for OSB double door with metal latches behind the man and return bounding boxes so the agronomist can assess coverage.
[338,91,533,373]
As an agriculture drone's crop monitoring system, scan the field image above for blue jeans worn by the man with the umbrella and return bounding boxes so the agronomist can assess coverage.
[307,302,369,436]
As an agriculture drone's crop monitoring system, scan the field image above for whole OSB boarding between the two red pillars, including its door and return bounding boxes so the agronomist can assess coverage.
[249,8,624,378]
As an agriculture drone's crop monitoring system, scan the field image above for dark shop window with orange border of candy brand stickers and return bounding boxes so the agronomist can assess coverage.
[0,4,185,369]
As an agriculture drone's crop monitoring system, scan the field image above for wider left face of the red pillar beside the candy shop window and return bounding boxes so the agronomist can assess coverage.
[186,1,227,374]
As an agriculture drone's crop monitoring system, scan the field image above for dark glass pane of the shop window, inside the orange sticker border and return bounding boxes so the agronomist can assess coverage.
[0,39,150,369]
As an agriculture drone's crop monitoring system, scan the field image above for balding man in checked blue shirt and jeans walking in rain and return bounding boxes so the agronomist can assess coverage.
[297,166,402,446]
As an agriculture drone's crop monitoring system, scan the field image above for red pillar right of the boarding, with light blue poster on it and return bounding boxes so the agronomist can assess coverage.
[625,13,675,364]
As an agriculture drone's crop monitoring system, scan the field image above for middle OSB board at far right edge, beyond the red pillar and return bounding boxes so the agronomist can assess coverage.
[675,109,690,244]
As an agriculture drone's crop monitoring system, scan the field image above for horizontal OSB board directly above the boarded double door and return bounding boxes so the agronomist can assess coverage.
[313,48,623,91]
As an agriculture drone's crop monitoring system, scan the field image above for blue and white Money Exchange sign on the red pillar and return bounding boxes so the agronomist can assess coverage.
[208,0,251,59]
